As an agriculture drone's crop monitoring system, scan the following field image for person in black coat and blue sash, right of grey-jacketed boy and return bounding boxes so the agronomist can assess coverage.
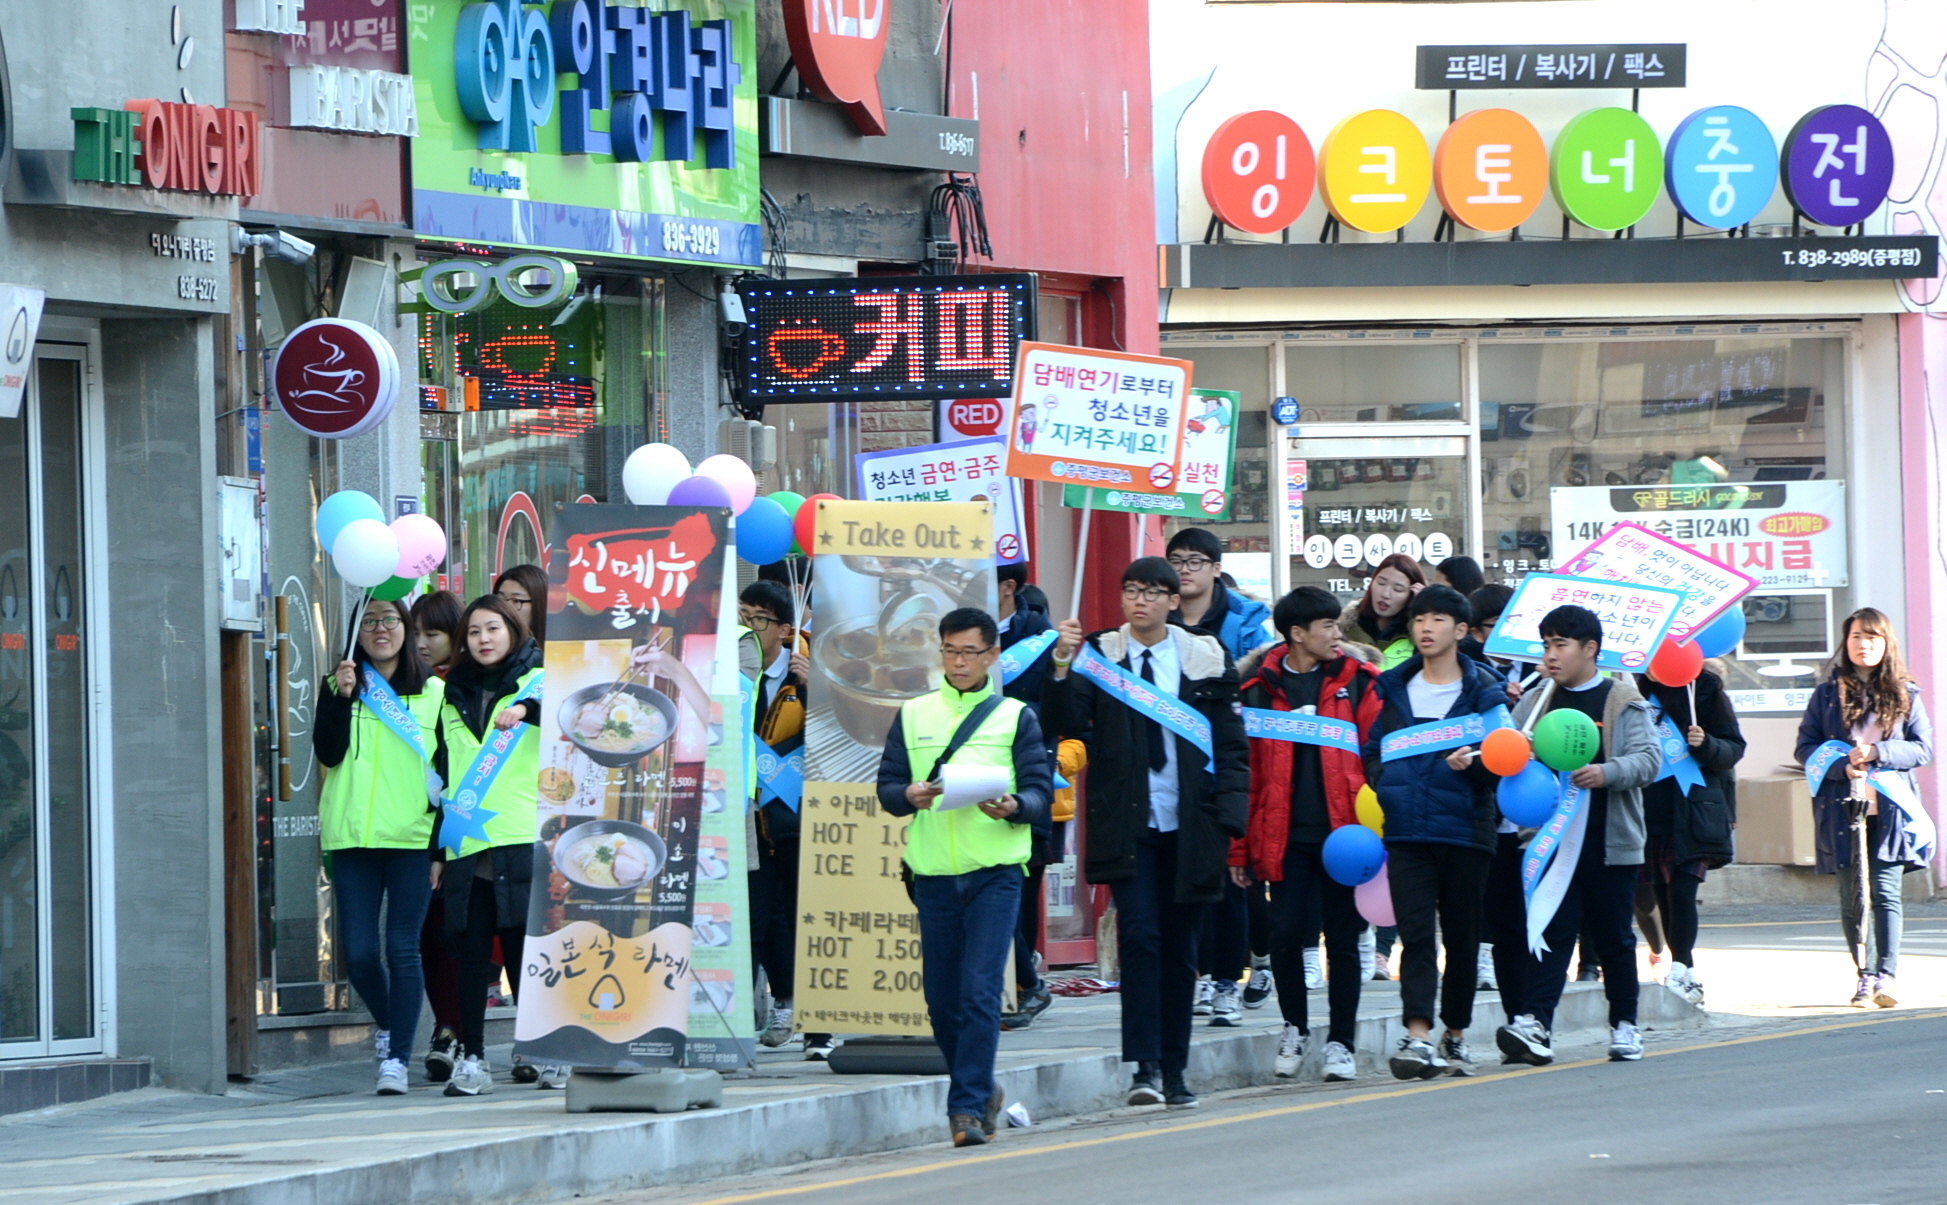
[1635,670,1745,1004]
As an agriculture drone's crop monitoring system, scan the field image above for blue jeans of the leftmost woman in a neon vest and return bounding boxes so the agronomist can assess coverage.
[331,849,432,1061]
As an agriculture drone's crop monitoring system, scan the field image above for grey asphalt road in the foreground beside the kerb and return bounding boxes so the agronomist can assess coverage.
[607,1008,1947,1205]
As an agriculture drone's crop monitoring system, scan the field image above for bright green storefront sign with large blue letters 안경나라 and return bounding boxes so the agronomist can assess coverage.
[401,0,763,267]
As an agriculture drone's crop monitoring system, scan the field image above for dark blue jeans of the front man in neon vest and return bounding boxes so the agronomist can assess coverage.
[913,866,1024,1117]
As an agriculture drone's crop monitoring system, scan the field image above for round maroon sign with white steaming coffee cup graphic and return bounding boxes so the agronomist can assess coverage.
[271,317,399,440]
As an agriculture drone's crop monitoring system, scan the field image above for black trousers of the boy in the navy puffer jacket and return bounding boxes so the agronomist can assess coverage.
[1386,841,1493,1030]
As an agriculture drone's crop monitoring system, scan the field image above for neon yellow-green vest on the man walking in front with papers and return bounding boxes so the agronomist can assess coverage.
[900,679,1034,874]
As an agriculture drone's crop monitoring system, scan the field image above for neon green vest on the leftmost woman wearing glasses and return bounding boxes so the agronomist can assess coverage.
[317,676,446,851]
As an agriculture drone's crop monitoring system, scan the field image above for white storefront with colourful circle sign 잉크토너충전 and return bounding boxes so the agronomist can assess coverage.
[1153,2,1939,876]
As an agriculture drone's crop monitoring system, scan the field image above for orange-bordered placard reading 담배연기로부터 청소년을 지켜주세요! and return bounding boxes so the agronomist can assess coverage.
[1007,343,1192,494]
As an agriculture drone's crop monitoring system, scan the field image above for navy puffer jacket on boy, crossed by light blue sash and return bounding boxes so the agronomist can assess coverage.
[1365,652,1507,853]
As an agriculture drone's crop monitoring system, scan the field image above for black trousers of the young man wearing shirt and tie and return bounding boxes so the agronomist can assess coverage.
[1110,829,1205,1075]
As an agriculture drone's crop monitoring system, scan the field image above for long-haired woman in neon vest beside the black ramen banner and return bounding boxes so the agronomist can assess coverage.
[440,594,541,1096]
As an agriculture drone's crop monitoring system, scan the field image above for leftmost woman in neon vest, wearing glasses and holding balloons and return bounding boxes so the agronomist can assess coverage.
[312,600,446,1096]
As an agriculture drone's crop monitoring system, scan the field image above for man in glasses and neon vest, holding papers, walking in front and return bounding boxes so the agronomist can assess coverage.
[878,607,1053,1147]
